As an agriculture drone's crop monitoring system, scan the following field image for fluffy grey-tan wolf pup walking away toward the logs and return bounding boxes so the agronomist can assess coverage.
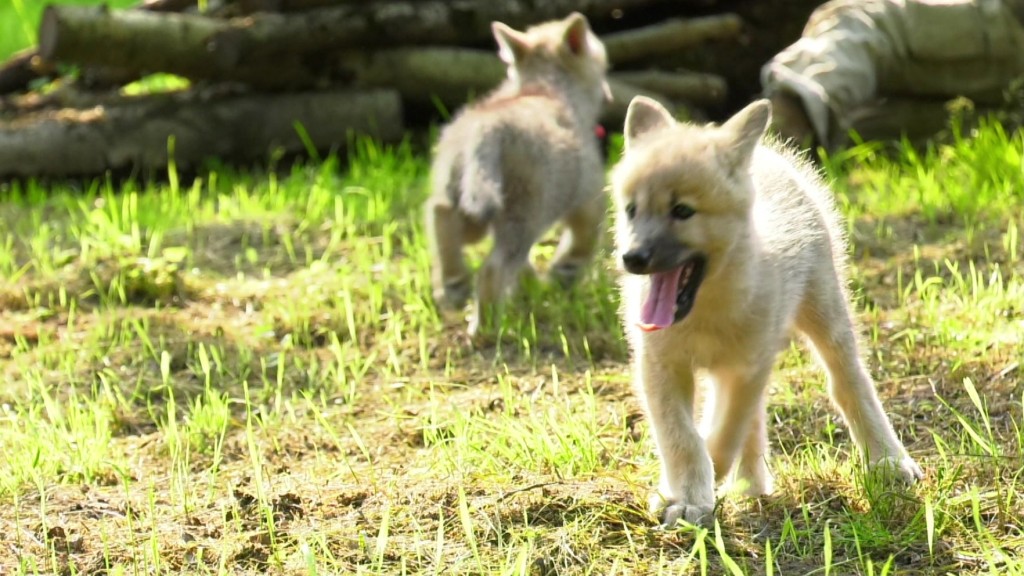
[426,12,608,334]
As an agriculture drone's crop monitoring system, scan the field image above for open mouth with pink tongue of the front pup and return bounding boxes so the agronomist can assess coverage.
[638,255,707,332]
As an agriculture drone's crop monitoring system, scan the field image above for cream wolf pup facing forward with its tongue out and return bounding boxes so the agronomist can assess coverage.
[612,97,923,525]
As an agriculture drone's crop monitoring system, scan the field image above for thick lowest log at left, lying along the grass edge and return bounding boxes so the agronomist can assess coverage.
[0,90,403,177]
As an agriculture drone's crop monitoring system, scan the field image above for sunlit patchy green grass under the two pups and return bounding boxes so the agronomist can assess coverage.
[0,0,1024,575]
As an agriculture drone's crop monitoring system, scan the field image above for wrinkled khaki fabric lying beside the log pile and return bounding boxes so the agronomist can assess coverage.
[761,0,1024,147]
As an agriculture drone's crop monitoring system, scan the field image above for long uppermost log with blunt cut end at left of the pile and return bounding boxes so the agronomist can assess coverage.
[39,0,704,88]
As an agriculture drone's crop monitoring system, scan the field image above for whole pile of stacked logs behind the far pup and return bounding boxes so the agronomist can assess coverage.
[0,0,816,177]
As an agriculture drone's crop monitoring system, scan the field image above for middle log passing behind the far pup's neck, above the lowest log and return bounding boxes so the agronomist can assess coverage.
[340,48,680,126]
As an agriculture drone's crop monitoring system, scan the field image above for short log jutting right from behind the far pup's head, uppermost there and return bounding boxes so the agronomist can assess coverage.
[601,14,742,65]
